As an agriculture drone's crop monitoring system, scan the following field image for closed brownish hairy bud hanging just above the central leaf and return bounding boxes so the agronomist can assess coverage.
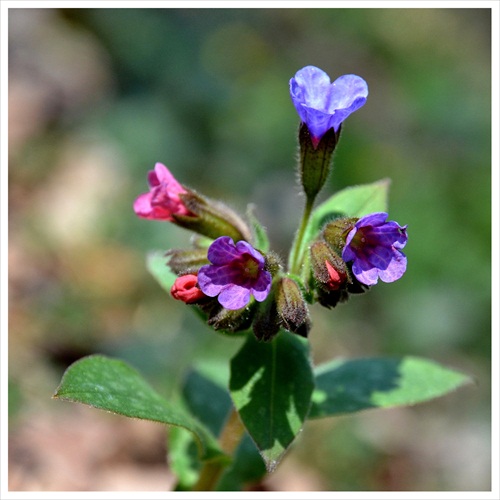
[276,277,311,337]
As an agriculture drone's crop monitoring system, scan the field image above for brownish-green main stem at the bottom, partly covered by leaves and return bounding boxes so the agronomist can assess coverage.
[193,408,245,491]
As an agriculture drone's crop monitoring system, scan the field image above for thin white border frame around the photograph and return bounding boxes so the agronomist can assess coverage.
[0,0,500,500]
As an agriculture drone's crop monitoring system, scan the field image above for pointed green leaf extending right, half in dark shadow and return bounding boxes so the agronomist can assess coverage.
[309,356,472,418]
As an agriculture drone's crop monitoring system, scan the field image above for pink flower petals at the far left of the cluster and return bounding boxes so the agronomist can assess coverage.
[134,163,190,222]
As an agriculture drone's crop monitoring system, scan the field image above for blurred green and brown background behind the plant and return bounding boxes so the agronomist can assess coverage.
[9,8,491,491]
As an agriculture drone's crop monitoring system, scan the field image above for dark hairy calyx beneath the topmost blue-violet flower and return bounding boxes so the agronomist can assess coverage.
[299,123,341,200]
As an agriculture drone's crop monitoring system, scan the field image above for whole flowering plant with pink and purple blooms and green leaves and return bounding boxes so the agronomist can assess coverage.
[55,66,470,490]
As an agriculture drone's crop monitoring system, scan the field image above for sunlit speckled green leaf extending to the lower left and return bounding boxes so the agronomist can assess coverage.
[54,355,226,460]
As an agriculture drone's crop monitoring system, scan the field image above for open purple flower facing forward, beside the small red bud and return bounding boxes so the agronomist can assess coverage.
[198,236,272,309]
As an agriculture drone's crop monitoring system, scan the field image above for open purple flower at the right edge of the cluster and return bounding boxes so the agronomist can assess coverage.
[342,212,408,285]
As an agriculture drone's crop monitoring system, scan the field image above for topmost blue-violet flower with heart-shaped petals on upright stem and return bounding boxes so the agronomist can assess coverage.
[290,66,368,147]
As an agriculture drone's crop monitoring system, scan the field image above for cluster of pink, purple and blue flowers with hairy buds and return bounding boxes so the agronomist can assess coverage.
[134,66,408,340]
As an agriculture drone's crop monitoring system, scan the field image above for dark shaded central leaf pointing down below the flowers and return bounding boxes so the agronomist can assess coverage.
[229,331,314,471]
